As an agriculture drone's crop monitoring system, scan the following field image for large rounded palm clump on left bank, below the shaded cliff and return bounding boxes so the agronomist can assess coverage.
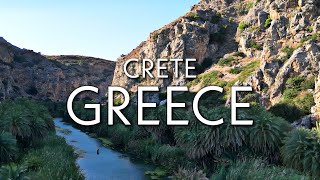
[0,99,54,148]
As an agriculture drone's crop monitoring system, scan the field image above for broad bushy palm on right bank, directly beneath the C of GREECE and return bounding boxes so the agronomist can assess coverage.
[175,107,247,158]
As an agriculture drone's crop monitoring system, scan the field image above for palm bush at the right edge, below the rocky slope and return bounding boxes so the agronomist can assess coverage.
[281,128,320,178]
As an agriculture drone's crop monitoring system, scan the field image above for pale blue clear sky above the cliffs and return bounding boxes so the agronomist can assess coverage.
[0,0,199,60]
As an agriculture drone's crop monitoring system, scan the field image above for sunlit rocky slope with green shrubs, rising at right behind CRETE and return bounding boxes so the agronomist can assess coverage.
[113,0,320,122]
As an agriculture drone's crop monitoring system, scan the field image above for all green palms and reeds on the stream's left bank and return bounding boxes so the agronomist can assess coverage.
[0,99,83,179]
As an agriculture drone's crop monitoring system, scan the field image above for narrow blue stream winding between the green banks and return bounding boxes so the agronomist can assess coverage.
[54,118,151,180]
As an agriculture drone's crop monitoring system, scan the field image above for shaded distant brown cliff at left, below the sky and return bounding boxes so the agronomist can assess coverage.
[0,38,115,101]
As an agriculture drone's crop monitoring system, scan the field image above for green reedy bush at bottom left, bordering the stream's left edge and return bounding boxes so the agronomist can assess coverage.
[22,134,84,180]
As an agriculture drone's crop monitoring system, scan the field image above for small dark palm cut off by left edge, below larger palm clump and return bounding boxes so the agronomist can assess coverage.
[0,132,17,162]
